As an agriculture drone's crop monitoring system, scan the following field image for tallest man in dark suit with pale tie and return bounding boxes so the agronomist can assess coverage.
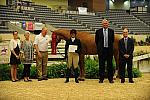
[95,19,114,83]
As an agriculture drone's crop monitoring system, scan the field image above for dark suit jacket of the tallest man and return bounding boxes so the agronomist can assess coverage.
[95,28,114,53]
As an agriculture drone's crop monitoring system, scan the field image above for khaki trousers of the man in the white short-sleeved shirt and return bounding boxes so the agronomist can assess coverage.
[36,52,48,78]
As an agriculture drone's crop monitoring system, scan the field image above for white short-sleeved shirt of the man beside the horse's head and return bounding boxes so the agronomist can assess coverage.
[33,33,51,51]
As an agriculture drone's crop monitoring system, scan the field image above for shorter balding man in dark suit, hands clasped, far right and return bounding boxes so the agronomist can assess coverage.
[118,28,134,83]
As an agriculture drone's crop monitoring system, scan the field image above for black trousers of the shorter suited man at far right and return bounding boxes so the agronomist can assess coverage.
[119,58,133,80]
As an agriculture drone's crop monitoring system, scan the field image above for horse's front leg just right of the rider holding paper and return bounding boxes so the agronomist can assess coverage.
[78,54,85,81]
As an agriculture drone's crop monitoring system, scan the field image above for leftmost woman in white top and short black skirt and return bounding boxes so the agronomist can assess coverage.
[10,31,20,82]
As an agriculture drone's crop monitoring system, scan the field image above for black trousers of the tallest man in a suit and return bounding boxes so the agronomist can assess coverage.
[98,48,114,81]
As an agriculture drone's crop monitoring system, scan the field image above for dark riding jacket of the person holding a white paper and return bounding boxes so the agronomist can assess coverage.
[65,38,81,57]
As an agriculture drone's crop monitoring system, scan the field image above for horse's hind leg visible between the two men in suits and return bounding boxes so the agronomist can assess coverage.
[114,50,119,78]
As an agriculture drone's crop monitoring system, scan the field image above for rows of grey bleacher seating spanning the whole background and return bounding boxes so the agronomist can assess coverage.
[0,3,150,34]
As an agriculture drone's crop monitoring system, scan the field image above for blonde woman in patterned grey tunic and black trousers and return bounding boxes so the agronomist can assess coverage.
[21,31,33,82]
